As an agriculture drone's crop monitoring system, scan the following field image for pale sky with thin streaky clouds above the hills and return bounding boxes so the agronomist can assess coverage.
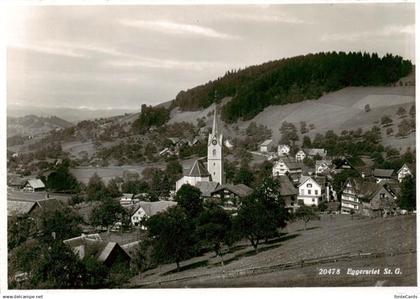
[6,3,415,110]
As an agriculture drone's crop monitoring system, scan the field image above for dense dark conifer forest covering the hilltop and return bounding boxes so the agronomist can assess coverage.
[174,52,413,122]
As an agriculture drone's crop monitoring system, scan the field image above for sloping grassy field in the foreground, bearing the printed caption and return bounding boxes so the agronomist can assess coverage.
[127,215,417,288]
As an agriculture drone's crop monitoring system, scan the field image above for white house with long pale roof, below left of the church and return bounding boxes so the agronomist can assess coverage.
[126,200,177,226]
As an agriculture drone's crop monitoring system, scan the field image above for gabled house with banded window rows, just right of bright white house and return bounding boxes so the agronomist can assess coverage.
[341,178,377,214]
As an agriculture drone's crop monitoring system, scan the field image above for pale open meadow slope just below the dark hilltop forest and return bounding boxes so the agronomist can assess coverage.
[170,86,415,151]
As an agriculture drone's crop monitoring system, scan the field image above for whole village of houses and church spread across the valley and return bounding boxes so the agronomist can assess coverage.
[7,106,415,287]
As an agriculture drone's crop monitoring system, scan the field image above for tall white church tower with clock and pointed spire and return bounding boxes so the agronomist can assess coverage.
[207,104,225,184]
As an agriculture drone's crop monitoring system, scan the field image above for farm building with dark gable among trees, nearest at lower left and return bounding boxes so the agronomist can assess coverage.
[63,234,131,268]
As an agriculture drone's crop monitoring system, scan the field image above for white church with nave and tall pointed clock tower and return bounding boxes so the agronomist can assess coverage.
[175,104,225,192]
